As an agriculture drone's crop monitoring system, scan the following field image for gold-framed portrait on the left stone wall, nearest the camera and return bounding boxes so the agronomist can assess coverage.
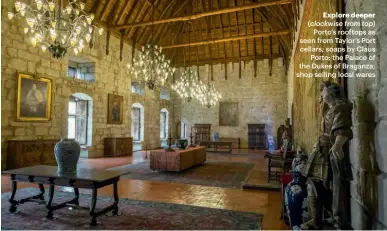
[16,73,52,122]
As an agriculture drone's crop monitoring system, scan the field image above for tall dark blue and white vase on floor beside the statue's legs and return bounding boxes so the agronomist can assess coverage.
[285,153,308,230]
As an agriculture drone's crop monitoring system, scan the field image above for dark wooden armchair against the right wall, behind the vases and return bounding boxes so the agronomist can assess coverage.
[266,141,293,183]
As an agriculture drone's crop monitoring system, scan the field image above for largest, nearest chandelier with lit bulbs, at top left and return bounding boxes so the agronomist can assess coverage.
[8,0,103,59]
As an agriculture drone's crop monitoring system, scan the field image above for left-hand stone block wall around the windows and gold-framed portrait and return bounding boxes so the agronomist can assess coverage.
[1,1,174,169]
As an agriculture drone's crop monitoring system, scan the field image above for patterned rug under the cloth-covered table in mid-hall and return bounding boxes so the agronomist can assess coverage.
[109,160,254,188]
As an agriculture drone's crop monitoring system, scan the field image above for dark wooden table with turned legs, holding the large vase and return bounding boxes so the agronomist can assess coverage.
[3,165,127,225]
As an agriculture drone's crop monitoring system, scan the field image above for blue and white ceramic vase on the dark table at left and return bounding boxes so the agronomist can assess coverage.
[54,138,81,173]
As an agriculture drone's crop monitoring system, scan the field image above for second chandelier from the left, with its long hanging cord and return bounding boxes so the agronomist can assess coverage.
[127,1,175,90]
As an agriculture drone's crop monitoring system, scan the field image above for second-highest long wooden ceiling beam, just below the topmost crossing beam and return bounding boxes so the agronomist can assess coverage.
[163,29,290,49]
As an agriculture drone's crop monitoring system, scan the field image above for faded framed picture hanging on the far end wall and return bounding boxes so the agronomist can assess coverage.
[219,102,238,127]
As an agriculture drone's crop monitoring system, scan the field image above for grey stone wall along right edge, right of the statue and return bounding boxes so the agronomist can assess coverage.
[345,0,387,229]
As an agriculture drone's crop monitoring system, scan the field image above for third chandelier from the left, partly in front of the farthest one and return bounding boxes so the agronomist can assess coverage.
[172,68,203,102]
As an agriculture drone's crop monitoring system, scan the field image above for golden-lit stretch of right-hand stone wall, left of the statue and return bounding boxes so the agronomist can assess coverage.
[289,0,336,153]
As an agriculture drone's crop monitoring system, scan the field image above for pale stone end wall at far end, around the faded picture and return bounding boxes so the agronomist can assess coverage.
[174,59,287,148]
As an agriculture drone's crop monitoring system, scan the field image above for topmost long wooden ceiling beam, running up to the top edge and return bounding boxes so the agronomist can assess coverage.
[114,0,292,29]
